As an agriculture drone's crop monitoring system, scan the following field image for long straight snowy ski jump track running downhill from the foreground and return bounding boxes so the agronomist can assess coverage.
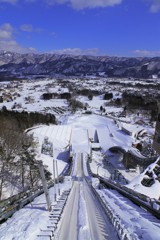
[56,153,118,240]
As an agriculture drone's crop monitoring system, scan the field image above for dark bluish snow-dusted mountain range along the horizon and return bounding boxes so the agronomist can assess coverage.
[0,51,160,80]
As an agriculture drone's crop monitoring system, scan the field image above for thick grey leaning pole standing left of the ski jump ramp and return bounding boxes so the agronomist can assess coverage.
[38,161,52,212]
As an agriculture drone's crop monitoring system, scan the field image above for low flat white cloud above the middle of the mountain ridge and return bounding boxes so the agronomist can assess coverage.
[50,48,99,56]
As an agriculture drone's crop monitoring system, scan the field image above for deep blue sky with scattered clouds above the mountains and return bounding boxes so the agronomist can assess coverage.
[0,0,160,57]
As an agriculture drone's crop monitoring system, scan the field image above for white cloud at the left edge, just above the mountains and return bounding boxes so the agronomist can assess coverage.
[0,23,35,53]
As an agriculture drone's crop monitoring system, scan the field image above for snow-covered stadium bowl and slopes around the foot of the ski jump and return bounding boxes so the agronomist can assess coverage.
[30,114,160,199]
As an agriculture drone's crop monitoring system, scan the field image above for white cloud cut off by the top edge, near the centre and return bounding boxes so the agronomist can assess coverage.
[46,0,123,10]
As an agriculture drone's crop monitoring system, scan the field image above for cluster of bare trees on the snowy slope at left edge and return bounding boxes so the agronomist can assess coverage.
[0,125,40,200]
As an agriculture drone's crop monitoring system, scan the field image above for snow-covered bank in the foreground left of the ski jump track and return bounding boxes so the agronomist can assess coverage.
[0,178,72,240]
